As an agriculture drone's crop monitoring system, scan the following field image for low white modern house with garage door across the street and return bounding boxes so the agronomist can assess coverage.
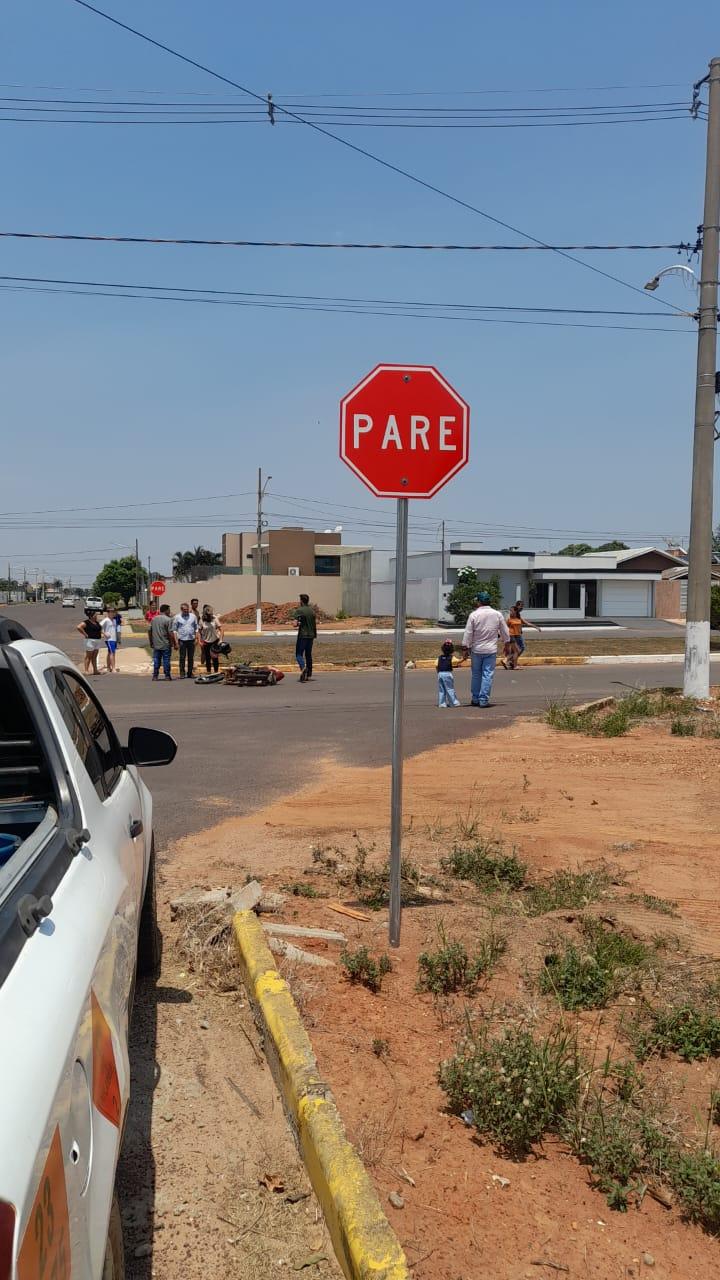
[372,543,678,623]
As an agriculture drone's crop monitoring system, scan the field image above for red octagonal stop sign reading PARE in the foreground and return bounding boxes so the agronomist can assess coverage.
[340,365,470,498]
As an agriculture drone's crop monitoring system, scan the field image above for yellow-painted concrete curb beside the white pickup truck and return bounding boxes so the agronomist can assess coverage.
[233,911,410,1280]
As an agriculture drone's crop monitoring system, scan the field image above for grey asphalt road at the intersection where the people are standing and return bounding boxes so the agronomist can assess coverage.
[4,605,702,845]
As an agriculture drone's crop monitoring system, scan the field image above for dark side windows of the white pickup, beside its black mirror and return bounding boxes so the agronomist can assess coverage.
[47,668,123,800]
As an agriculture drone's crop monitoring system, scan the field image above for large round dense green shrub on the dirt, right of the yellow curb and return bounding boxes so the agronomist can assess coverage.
[438,1027,582,1160]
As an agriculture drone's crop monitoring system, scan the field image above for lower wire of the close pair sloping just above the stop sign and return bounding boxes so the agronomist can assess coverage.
[0,284,692,334]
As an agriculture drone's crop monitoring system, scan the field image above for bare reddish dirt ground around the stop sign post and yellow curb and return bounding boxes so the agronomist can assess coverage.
[124,722,720,1280]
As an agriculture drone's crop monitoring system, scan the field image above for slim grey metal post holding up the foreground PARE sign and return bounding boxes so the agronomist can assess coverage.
[389,498,407,947]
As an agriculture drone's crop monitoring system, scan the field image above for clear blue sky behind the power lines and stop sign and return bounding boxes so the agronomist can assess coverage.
[0,0,720,581]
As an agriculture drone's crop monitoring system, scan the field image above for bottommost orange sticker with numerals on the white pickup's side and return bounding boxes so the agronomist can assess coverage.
[18,1128,72,1280]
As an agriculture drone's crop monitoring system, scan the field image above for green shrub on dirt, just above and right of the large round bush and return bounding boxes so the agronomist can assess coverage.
[539,920,648,1009]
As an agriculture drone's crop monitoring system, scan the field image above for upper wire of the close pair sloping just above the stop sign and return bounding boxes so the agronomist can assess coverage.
[0,275,686,317]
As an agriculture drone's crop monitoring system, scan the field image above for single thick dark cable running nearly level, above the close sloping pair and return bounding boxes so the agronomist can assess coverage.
[0,230,698,253]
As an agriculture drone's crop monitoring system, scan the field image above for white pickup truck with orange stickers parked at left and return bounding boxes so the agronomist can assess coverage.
[0,620,177,1280]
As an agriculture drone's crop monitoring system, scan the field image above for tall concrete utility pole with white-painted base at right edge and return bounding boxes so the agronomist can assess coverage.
[683,58,720,698]
